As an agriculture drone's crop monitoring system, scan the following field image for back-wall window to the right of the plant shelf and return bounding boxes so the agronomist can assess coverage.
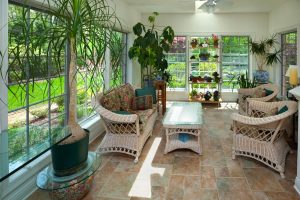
[221,36,249,91]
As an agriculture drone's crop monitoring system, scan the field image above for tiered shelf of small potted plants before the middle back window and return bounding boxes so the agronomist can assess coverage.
[188,34,222,104]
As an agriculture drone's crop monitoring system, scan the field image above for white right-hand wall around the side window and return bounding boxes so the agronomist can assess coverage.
[269,0,300,91]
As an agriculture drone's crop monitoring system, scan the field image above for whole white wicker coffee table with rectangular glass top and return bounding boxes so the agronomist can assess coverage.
[162,102,203,155]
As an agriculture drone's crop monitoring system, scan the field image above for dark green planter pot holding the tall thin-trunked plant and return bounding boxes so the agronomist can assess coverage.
[51,130,89,176]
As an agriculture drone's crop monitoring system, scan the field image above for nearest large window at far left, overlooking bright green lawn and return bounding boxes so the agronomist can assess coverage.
[6,4,66,171]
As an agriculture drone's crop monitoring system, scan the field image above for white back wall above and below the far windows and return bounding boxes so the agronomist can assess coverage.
[136,13,269,101]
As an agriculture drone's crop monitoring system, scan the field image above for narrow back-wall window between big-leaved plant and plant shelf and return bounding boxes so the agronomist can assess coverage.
[166,36,186,90]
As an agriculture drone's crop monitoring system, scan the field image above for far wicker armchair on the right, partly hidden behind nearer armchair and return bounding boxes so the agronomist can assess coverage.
[238,83,279,115]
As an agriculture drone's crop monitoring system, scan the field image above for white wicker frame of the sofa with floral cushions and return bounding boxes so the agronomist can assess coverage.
[93,90,157,163]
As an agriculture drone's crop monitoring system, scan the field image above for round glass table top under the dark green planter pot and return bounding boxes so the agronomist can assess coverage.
[36,152,101,190]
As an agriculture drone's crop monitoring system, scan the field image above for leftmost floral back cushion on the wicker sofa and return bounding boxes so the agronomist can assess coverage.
[100,89,121,111]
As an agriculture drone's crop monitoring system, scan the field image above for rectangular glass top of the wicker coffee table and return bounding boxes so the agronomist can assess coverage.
[163,102,203,125]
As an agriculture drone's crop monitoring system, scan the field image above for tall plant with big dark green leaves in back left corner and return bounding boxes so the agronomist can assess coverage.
[128,12,174,85]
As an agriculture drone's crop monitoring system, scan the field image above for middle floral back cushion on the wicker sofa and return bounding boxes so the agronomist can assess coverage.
[118,83,135,110]
